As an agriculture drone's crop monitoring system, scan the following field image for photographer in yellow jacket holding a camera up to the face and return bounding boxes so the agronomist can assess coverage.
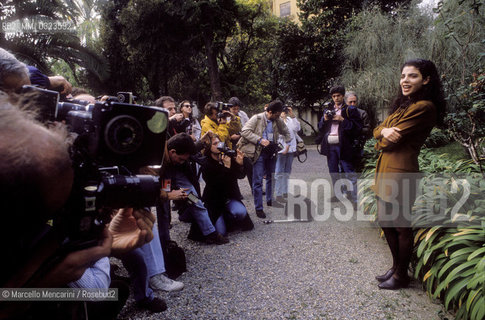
[200,102,241,148]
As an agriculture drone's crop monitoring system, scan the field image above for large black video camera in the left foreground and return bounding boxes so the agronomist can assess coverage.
[23,86,168,251]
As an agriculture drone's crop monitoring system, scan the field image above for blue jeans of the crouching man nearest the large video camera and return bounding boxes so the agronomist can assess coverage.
[173,171,216,236]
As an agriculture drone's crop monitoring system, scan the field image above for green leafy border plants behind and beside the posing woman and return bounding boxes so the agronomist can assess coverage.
[359,140,485,320]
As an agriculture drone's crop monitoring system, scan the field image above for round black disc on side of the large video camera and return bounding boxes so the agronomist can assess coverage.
[104,115,143,155]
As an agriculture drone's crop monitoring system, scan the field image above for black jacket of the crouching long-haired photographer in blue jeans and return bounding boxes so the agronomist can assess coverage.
[201,157,246,221]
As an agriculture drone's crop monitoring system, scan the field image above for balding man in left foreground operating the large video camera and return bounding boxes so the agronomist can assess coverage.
[0,97,154,318]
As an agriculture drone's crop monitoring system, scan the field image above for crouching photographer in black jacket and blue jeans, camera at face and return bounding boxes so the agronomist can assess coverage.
[201,132,254,235]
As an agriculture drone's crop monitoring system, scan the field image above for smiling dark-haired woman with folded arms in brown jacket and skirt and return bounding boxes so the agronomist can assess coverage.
[373,59,445,290]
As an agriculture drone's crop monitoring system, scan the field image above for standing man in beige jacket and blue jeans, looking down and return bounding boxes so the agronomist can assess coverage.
[237,100,291,218]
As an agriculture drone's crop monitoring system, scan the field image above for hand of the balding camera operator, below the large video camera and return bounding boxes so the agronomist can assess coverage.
[109,208,155,256]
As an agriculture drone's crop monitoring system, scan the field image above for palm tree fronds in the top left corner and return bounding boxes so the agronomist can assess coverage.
[0,0,108,85]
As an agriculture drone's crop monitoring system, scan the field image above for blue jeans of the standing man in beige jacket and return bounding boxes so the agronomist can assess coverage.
[253,155,276,210]
